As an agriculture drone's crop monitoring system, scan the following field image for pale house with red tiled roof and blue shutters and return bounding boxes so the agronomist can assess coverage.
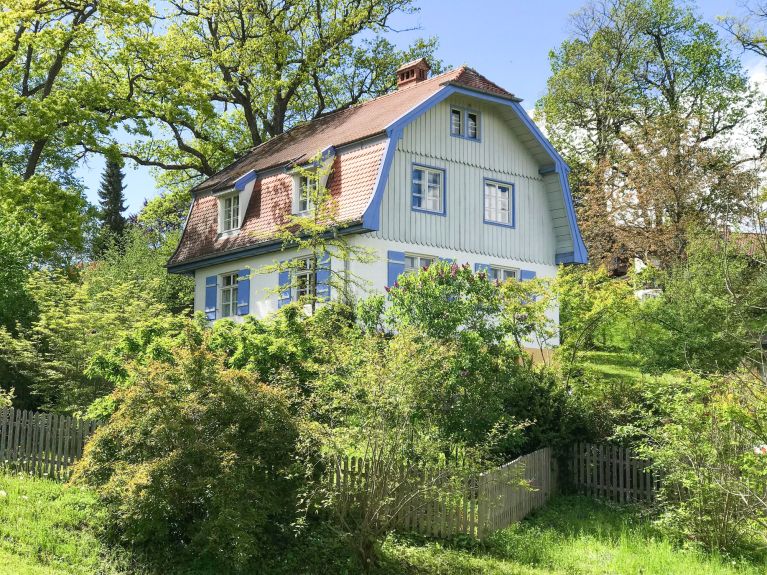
[168,59,587,338]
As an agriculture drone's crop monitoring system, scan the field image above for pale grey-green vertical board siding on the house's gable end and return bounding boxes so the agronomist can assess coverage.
[375,97,572,264]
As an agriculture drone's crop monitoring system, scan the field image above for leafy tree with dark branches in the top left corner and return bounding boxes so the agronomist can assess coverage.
[0,0,151,180]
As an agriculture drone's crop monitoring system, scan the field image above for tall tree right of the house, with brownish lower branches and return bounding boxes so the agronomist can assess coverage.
[538,0,765,265]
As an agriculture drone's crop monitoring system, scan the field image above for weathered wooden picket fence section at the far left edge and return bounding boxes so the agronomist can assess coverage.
[0,407,97,479]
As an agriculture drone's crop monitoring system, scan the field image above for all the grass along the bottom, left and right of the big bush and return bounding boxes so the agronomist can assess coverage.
[0,475,767,575]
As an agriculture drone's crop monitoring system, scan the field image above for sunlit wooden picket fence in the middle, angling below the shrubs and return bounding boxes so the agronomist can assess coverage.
[330,448,556,538]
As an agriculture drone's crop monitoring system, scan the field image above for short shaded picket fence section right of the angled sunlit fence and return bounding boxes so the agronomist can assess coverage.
[570,443,657,503]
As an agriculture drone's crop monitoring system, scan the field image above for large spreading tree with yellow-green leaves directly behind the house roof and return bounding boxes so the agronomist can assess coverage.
[110,0,439,188]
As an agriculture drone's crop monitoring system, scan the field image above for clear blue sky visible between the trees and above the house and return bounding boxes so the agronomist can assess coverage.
[80,0,764,213]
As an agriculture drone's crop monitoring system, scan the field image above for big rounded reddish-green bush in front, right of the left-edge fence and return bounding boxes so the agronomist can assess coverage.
[74,322,299,569]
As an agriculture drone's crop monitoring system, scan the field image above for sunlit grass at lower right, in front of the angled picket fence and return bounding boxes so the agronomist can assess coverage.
[385,497,767,575]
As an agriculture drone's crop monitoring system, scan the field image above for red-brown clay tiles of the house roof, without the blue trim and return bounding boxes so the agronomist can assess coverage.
[168,66,517,267]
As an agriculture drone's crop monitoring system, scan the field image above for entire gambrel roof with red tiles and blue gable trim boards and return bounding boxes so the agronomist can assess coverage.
[168,66,586,272]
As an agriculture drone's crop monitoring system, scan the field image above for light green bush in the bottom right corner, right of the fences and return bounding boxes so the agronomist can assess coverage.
[627,373,767,552]
